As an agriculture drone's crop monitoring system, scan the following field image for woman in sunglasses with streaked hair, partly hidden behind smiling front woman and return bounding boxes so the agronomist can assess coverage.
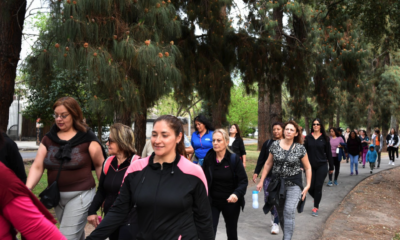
[87,123,139,240]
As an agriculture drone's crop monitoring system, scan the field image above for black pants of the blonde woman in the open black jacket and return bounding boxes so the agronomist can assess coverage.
[211,202,240,240]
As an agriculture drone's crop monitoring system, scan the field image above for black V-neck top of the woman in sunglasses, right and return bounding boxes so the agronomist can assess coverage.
[304,133,335,171]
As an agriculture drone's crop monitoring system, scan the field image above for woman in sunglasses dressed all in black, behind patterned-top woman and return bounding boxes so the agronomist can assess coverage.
[304,118,334,217]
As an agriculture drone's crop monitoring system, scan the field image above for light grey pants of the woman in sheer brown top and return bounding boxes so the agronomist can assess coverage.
[54,188,96,240]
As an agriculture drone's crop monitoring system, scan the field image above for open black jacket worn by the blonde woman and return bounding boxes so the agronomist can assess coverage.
[203,149,249,210]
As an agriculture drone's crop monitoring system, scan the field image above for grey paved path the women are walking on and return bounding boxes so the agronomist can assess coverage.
[216,157,399,240]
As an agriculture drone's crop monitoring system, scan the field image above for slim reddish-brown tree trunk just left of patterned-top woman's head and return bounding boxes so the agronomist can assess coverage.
[257,78,271,150]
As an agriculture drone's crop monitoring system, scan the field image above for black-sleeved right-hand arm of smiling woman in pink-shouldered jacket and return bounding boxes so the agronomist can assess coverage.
[193,179,215,240]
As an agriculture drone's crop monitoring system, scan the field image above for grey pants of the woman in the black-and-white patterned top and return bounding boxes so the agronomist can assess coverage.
[276,186,301,240]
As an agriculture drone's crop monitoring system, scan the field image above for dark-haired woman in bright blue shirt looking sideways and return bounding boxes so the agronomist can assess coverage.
[191,115,214,166]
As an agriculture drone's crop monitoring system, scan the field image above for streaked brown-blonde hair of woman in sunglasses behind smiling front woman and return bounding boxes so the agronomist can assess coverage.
[110,123,136,157]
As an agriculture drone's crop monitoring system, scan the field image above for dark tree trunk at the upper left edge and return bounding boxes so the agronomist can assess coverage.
[0,0,26,131]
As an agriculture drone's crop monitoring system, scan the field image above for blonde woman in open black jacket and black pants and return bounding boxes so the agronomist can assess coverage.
[203,129,248,240]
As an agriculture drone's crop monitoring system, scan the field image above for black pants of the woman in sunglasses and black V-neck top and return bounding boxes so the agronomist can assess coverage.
[308,164,328,208]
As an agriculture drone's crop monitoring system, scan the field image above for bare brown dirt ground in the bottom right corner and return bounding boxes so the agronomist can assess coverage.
[321,168,400,240]
